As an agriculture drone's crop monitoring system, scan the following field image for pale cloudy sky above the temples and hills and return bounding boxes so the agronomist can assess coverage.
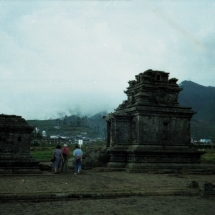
[0,0,215,119]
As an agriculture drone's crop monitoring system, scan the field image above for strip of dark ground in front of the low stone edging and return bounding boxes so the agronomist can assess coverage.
[0,196,215,215]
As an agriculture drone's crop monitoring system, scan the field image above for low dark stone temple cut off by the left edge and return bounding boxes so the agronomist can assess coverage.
[0,114,41,174]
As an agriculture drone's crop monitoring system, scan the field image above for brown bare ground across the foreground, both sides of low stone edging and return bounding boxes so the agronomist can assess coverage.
[0,170,215,215]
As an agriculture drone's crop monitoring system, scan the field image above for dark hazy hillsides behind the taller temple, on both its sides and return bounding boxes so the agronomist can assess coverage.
[28,81,215,141]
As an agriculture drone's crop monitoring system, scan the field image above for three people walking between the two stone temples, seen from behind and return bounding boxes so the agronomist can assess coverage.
[52,144,83,174]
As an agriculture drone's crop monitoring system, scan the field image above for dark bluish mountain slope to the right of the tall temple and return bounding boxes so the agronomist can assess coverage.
[178,81,215,140]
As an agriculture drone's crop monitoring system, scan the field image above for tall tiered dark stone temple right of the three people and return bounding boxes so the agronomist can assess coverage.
[104,70,210,172]
